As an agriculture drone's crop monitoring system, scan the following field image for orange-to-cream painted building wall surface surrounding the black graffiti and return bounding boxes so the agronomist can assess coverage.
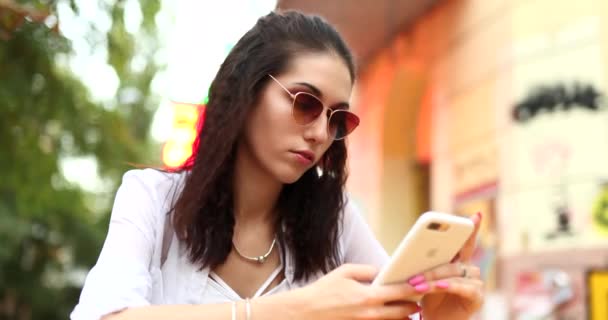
[349,0,608,254]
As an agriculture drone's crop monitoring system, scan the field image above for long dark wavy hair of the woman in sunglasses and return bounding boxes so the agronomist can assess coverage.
[172,11,355,280]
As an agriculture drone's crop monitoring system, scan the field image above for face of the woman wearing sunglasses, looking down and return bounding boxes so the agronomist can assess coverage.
[242,53,352,183]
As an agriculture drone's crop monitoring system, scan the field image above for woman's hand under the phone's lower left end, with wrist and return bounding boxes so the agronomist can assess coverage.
[294,264,418,320]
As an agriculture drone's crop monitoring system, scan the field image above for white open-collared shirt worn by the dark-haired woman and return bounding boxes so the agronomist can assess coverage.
[70,169,388,320]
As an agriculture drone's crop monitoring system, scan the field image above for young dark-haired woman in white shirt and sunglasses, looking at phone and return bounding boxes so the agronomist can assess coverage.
[71,12,483,320]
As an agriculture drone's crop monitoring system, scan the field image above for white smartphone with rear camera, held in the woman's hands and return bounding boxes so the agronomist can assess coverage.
[372,211,475,285]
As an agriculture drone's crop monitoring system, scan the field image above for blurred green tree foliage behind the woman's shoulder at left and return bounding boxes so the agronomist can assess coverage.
[0,0,160,319]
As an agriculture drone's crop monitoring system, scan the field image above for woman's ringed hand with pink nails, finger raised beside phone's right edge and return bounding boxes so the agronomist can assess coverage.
[409,213,483,320]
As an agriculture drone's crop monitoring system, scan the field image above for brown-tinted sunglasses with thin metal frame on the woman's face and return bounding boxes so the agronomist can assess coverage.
[268,74,360,140]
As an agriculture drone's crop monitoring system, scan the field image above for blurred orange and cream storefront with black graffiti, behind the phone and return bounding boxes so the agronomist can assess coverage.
[279,0,608,319]
